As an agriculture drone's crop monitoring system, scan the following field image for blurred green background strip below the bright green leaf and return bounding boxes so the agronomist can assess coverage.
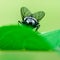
[0,51,60,60]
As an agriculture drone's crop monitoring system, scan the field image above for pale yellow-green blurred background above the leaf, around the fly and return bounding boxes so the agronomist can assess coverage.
[0,0,60,32]
